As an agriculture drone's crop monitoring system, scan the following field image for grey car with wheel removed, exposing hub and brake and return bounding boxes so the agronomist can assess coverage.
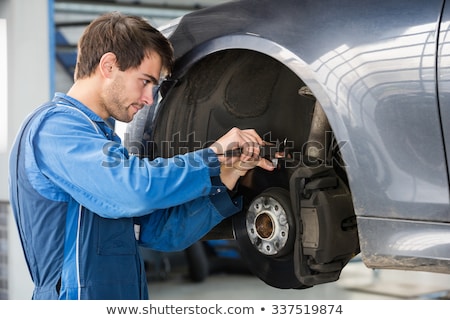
[125,0,450,289]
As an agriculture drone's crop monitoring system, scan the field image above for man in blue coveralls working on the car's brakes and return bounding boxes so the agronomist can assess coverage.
[10,12,273,299]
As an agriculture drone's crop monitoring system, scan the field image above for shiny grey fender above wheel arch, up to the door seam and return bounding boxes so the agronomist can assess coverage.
[165,0,450,222]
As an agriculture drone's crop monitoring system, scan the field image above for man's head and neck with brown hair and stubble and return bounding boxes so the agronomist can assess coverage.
[68,12,173,122]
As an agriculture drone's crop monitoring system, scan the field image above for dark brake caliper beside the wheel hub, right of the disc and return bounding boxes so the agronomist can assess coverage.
[290,166,360,286]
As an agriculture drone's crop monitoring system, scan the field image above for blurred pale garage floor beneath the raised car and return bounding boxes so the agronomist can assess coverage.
[149,255,450,300]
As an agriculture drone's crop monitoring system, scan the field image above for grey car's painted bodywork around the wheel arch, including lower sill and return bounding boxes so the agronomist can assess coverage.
[144,0,450,273]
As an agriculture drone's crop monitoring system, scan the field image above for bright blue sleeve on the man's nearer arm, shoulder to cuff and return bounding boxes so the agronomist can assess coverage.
[29,108,236,218]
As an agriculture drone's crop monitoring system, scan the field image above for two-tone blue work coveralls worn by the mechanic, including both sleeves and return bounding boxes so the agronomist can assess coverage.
[9,93,241,300]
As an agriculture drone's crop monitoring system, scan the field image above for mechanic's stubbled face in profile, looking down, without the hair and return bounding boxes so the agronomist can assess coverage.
[103,53,161,122]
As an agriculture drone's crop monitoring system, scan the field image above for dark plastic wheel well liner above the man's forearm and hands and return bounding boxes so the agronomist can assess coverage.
[155,49,315,156]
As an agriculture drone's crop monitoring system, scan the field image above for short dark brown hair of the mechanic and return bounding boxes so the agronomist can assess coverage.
[75,12,173,79]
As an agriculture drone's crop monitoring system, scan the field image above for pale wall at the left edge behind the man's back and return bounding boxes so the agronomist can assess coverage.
[0,0,52,299]
